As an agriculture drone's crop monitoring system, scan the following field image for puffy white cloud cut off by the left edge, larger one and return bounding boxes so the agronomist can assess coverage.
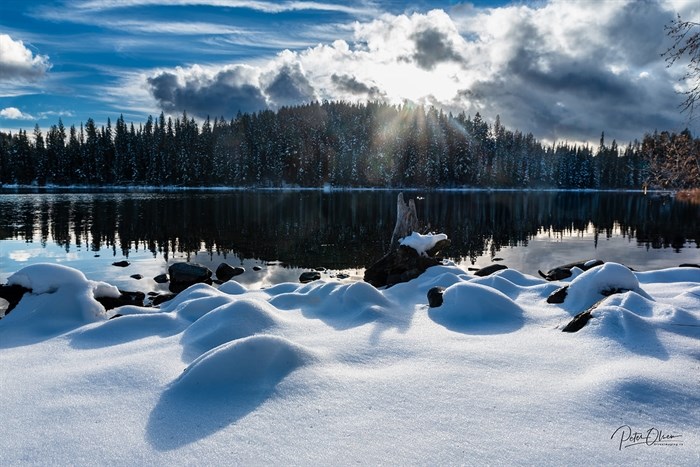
[0,34,51,81]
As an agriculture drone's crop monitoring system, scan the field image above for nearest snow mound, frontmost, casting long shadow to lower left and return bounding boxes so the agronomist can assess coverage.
[173,335,314,397]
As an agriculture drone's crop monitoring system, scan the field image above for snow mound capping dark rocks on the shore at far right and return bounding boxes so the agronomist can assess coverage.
[564,263,651,313]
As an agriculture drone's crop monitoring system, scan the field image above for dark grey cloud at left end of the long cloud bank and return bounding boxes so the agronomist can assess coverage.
[148,67,267,117]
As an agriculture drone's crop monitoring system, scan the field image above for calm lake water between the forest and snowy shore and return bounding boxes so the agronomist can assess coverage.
[0,190,700,290]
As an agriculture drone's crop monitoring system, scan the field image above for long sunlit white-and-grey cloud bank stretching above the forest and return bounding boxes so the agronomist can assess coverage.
[141,0,683,142]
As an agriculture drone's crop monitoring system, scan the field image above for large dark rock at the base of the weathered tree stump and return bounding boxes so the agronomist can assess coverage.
[364,245,442,287]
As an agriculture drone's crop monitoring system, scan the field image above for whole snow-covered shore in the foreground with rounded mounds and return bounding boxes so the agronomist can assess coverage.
[0,263,700,465]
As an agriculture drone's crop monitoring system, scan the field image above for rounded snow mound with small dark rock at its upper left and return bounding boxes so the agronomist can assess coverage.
[428,282,524,334]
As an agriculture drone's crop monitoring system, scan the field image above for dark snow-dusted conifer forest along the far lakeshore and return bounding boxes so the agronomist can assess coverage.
[0,101,700,190]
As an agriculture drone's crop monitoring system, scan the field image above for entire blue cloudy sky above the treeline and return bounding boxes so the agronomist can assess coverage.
[0,0,700,144]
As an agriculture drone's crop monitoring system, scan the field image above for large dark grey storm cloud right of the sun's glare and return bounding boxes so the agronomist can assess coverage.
[459,1,683,143]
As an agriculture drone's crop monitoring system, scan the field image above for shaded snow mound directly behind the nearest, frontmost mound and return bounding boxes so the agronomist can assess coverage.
[182,298,279,359]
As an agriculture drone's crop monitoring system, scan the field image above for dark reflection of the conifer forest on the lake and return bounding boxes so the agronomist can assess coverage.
[0,191,700,269]
